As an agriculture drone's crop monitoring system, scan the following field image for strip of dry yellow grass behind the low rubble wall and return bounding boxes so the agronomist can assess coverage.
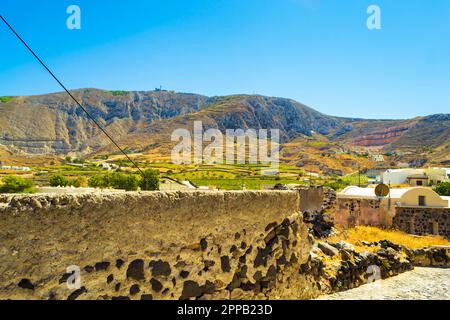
[329,226,450,249]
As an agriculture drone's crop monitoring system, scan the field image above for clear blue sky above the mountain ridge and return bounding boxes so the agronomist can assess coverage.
[0,0,450,118]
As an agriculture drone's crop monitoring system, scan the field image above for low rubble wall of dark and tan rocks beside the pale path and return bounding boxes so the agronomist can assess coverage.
[300,240,450,294]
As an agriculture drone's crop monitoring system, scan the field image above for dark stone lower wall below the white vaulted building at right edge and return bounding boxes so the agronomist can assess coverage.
[393,207,450,239]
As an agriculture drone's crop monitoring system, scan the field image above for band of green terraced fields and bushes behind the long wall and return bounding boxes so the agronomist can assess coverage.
[15,158,368,191]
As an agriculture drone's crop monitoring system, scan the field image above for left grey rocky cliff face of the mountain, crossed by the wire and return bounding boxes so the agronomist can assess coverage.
[0,89,208,154]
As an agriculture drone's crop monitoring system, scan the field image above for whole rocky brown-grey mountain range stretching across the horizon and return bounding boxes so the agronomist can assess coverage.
[0,89,450,166]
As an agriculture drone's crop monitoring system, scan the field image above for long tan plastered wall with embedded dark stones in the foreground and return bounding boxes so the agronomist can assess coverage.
[0,191,318,299]
